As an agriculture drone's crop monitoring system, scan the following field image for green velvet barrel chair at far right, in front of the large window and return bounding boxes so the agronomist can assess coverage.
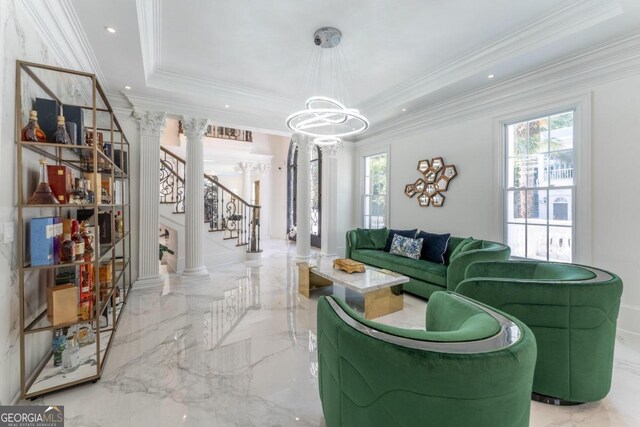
[456,261,622,405]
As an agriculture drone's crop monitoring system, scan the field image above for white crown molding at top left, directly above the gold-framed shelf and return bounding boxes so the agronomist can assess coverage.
[21,0,110,92]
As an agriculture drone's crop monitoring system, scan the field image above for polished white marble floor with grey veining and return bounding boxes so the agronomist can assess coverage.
[22,242,640,427]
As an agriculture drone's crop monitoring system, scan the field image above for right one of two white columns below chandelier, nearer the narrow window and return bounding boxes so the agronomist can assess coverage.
[320,143,342,256]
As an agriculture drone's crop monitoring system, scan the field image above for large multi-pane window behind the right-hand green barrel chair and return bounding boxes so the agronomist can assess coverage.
[505,110,576,262]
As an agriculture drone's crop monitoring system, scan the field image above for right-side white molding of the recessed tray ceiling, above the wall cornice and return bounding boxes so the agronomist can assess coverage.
[360,0,624,116]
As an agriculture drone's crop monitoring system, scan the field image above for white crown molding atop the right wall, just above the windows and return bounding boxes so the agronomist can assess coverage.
[357,32,640,147]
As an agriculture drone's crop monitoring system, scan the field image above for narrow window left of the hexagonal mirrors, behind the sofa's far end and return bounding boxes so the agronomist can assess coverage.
[363,153,387,228]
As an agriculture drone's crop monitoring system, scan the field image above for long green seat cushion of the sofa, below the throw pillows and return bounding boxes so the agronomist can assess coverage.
[351,249,447,286]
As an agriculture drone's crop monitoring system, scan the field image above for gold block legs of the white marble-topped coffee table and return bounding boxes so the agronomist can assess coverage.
[298,263,404,319]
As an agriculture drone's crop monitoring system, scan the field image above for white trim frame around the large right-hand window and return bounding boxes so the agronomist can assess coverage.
[493,92,592,265]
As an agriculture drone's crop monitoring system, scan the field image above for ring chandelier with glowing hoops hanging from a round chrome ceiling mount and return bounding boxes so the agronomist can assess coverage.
[286,27,369,145]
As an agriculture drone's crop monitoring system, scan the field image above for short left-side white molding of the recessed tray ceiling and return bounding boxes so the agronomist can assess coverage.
[136,0,162,79]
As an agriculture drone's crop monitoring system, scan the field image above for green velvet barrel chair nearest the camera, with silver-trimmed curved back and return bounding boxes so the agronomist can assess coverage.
[317,292,536,427]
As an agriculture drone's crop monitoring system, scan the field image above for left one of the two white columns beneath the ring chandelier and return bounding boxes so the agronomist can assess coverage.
[294,135,312,262]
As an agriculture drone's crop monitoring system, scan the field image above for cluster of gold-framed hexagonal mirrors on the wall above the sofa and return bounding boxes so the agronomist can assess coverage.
[404,157,458,208]
